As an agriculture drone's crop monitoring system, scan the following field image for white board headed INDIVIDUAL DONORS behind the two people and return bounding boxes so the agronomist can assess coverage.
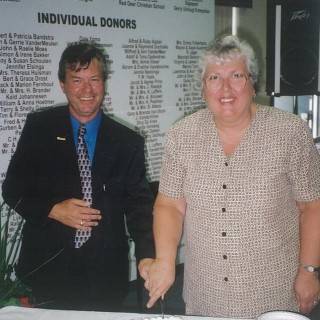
[0,0,214,276]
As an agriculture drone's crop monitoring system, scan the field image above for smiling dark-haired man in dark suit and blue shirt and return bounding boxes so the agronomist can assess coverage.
[2,43,153,311]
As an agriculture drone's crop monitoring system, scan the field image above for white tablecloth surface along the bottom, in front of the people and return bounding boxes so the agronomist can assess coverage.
[0,306,250,320]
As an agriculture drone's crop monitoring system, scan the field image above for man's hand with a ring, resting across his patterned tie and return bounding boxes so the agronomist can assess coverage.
[49,199,101,230]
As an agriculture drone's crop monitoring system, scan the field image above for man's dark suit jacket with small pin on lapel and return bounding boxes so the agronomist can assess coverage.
[2,106,154,290]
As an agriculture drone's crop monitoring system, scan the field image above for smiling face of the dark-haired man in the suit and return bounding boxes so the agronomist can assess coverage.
[60,59,105,123]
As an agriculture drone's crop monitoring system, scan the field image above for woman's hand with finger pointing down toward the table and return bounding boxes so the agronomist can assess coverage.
[139,259,175,308]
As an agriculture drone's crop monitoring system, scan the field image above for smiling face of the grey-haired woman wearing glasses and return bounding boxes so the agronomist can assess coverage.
[203,57,255,122]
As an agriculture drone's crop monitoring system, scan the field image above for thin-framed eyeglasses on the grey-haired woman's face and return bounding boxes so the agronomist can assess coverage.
[205,72,250,92]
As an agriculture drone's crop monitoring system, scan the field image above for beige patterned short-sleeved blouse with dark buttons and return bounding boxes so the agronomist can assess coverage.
[160,106,320,318]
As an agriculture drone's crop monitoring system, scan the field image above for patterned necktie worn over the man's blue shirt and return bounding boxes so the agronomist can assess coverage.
[74,124,92,248]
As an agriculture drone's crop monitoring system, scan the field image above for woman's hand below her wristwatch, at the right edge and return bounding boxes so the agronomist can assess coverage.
[294,269,320,314]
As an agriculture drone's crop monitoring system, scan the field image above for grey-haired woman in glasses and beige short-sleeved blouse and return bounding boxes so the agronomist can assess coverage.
[140,36,320,318]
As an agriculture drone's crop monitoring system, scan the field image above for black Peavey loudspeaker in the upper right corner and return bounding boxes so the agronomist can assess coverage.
[267,0,320,96]
